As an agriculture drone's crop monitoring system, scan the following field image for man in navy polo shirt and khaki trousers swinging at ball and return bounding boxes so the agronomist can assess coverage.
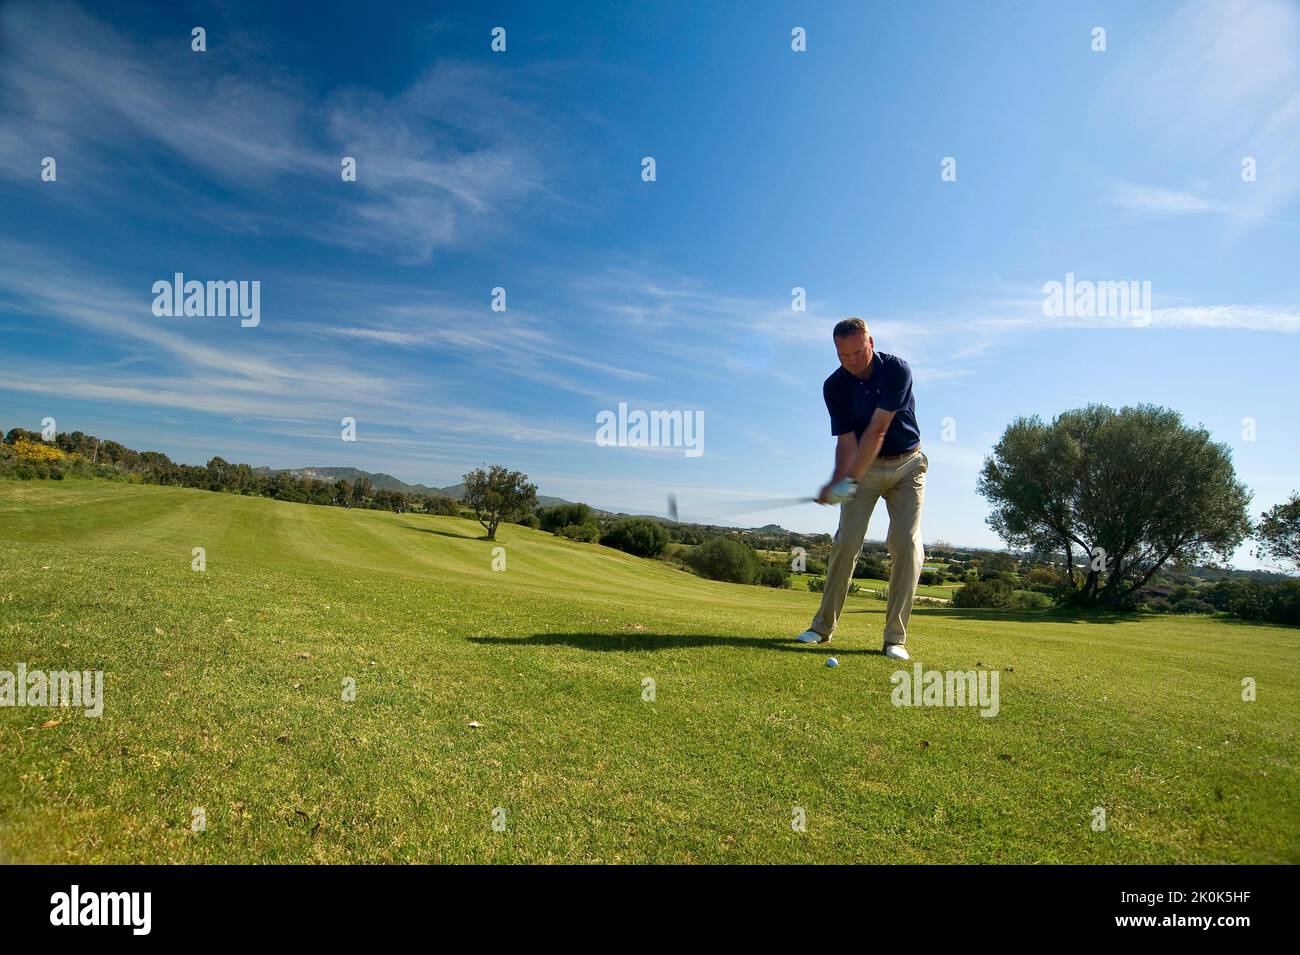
[797,318,930,660]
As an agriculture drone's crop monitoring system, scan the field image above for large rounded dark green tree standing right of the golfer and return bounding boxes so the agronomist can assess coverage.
[979,404,1251,605]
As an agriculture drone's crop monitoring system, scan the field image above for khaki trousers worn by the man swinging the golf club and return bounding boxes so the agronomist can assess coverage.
[811,448,930,643]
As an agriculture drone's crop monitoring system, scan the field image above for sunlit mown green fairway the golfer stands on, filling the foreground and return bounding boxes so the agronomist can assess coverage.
[0,481,1300,863]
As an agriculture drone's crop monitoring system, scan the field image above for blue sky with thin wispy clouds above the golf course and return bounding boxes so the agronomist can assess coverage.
[0,0,1300,567]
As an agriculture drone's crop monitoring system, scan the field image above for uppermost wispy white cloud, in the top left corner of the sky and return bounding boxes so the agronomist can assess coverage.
[0,3,563,261]
